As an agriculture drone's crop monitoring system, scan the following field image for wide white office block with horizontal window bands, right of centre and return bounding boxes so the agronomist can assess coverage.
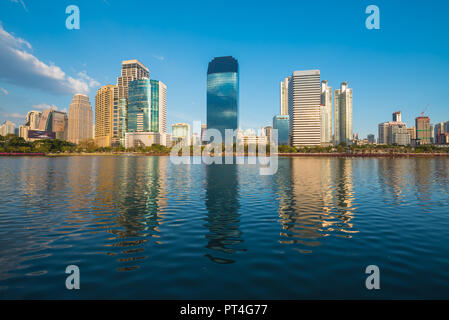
[288,70,321,147]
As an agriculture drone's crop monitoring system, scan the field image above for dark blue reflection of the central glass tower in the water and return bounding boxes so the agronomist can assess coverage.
[205,164,245,264]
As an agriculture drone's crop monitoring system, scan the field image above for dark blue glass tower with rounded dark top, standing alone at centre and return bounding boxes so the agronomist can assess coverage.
[207,56,239,140]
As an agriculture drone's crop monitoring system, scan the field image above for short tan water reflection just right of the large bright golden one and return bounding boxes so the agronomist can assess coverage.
[377,158,410,203]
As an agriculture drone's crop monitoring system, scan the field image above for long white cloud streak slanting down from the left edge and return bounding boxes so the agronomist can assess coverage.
[0,24,99,94]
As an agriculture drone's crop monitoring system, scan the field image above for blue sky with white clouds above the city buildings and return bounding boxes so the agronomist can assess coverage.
[0,0,449,137]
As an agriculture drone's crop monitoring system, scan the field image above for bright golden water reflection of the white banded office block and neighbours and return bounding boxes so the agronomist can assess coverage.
[277,158,355,252]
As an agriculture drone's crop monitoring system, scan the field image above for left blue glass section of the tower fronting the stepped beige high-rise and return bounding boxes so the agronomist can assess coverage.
[127,79,151,132]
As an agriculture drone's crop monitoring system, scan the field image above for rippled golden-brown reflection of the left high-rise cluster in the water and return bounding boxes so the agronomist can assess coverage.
[95,157,167,271]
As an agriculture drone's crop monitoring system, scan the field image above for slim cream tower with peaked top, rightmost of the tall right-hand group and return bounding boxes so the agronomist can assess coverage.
[334,82,353,144]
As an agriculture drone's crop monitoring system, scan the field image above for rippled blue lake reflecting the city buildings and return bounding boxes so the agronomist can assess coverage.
[0,156,449,299]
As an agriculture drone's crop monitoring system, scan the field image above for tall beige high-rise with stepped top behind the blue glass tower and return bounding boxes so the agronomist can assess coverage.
[111,59,150,146]
